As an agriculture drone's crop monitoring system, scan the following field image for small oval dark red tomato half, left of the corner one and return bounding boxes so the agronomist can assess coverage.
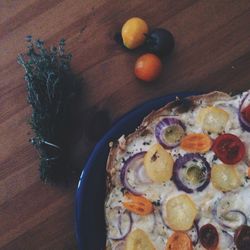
[200,224,219,250]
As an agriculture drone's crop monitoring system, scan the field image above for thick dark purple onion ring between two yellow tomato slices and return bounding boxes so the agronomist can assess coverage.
[173,154,211,193]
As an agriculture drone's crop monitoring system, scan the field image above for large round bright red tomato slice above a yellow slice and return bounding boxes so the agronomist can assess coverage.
[213,134,246,164]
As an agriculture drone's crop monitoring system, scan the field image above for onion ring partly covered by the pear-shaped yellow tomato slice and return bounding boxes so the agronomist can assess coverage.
[120,152,152,195]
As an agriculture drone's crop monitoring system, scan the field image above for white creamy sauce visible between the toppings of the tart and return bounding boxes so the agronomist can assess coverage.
[105,93,250,250]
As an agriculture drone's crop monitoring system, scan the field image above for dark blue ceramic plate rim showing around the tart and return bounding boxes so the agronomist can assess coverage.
[75,93,195,250]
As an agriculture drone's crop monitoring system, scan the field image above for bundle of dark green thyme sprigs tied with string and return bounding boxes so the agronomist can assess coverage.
[17,36,80,183]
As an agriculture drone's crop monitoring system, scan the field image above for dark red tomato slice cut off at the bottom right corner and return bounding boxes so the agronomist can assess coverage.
[234,225,250,250]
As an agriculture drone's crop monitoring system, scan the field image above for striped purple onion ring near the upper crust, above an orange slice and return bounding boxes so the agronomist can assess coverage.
[155,117,185,149]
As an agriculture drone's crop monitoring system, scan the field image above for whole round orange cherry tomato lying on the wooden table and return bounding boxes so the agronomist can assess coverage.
[134,53,162,82]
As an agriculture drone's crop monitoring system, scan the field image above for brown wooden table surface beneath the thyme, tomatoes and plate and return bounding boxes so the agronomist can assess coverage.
[0,0,250,250]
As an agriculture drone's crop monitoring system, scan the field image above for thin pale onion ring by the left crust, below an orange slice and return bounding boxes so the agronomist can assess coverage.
[107,206,132,240]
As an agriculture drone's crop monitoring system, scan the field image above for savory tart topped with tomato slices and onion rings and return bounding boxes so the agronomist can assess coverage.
[105,91,250,250]
